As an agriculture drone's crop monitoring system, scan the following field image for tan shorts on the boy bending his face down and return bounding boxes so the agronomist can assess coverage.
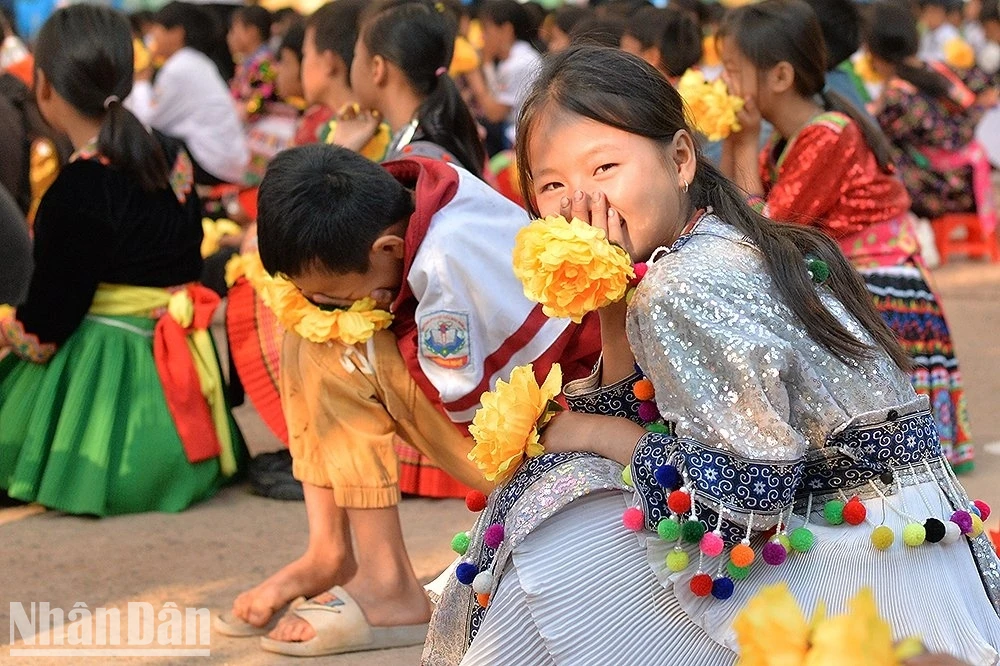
[280,331,489,509]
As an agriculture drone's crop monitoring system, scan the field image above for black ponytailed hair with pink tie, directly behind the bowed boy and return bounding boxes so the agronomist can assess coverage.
[361,0,486,178]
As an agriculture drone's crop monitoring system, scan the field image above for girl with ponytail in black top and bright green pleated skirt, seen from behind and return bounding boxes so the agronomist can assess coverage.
[0,5,242,516]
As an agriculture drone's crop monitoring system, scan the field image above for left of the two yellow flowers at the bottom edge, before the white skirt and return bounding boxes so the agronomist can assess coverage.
[733,583,812,666]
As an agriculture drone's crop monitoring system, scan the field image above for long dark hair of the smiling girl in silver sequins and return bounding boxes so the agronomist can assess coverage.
[515,46,909,368]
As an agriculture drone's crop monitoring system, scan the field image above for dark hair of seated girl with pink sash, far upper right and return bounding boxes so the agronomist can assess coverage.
[865,0,951,99]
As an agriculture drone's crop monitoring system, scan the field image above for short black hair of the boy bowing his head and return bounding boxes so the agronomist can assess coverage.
[257,145,413,277]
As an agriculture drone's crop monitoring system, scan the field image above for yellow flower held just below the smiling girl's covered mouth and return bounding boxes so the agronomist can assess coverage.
[514,215,635,323]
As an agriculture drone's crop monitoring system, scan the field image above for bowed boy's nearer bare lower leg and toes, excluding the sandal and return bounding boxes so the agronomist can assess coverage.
[269,507,431,641]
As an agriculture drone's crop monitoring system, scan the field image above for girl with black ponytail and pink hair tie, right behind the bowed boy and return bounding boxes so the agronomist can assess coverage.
[351,0,486,177]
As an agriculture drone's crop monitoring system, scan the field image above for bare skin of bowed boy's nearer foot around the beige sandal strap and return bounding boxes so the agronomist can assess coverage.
[267,577,431,643]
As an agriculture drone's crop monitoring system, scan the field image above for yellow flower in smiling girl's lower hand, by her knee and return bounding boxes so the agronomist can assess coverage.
[469,363,562,481]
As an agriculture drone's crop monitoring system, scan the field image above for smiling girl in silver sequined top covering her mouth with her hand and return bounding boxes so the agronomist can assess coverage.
[424,47,1000,666]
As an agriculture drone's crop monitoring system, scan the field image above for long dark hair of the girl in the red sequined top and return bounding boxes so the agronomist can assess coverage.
[719,0,892,170]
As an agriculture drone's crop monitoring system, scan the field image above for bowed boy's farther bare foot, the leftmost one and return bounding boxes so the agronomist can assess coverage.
[233,555,357,627]
